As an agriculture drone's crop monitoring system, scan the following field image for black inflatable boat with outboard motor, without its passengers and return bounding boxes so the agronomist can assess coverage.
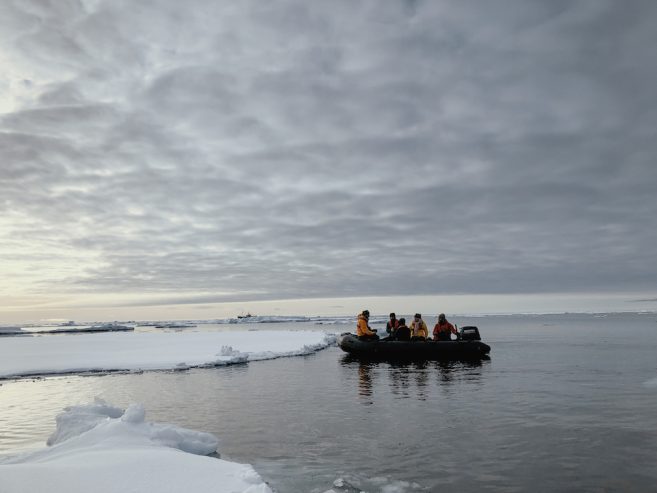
[338,326,490,360]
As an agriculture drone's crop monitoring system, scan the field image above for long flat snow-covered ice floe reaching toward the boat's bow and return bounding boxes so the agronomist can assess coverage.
[0,330,335,378]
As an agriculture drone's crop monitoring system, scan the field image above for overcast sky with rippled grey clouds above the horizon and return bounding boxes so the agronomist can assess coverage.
[0,0,657,322]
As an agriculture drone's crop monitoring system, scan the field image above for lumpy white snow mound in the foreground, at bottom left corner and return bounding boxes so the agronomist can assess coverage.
[0,401,271,493]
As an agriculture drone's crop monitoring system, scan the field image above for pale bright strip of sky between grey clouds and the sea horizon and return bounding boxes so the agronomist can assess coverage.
[0,293,657,324]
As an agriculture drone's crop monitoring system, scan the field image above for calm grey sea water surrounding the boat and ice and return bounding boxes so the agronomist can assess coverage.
[0,314,657,493]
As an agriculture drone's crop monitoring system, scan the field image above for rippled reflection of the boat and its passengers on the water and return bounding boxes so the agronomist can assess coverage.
[340,355,490,405]
